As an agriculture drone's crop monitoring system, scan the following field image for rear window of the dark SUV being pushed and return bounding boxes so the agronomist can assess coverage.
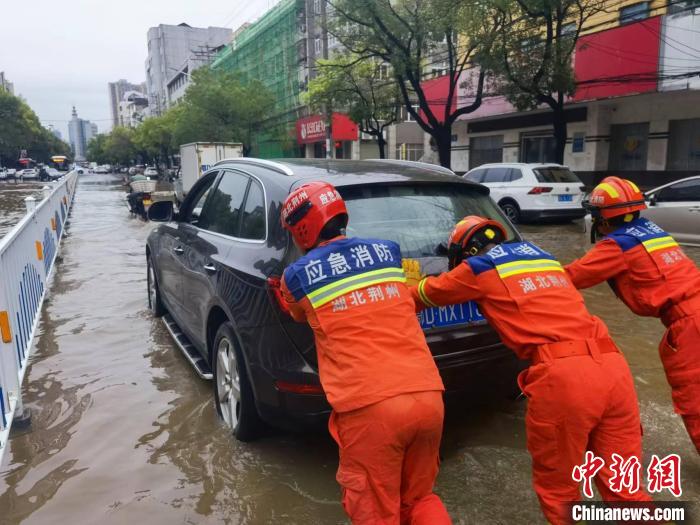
[338,184,515,257]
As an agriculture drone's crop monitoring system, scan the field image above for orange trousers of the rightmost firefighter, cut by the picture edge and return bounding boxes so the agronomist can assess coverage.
[659,314,700,454]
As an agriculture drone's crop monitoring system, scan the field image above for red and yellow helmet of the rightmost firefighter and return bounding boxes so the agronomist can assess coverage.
[584,177,647,219]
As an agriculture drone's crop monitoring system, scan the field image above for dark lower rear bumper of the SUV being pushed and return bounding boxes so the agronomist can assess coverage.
[254,343,527,431]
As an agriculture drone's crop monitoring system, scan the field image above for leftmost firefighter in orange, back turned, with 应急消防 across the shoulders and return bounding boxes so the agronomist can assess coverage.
[282,182,451,525]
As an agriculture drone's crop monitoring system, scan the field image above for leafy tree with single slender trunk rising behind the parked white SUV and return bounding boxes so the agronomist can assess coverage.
[485,0,605,163]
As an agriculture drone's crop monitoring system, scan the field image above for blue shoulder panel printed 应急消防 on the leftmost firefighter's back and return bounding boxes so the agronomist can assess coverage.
[284,238,402,301]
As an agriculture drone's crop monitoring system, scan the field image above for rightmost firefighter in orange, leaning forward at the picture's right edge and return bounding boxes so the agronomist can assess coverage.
[565,177,700,453]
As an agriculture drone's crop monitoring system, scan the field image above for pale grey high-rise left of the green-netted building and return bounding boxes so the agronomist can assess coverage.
[145,23,232,115]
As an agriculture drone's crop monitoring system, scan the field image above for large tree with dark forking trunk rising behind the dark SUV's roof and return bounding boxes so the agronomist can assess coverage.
[326,0,498,167]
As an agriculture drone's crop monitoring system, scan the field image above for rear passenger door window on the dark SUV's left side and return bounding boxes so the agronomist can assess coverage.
[198,172,250,237]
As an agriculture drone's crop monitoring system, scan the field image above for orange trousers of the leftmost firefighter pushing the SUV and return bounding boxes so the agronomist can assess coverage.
[328,392,452,525]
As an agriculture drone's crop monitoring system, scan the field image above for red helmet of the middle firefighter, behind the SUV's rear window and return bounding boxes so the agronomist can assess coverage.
[447,215,508,270]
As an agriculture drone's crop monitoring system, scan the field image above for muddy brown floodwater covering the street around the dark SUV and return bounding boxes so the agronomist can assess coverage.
[0,175,700,525]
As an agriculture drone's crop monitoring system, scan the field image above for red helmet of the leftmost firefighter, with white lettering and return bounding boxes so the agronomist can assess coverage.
[281,182,348,250]
